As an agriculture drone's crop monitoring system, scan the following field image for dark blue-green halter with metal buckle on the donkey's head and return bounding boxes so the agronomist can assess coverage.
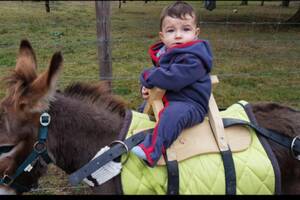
[0,112,52,192]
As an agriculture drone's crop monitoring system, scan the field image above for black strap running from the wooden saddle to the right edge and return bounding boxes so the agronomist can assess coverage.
[223,118,300,154]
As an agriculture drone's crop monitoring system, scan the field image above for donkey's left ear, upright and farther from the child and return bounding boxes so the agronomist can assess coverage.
[15,39,37,83]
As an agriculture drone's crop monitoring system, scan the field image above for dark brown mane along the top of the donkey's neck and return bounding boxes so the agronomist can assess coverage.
[63,81,127,116]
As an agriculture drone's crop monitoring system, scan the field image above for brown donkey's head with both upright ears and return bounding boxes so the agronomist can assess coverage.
[0,40,63,194]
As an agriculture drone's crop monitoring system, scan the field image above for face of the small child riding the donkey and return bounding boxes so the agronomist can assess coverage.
[159,15,200,48]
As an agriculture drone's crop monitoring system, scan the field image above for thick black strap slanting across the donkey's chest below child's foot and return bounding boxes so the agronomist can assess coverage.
[69,131,146,186]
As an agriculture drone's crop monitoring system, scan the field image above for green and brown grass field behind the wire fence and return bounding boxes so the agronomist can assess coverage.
[0,1,300,194]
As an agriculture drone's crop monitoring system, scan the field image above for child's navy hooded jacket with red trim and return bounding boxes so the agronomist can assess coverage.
[140,40,213,113]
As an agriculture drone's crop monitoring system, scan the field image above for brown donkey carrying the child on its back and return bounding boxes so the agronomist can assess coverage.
[0,40,300,194]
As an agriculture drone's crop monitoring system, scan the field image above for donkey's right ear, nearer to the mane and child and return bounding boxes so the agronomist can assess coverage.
[24,52,63,112]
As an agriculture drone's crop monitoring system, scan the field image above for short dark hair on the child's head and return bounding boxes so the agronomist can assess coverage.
[160,1,198,30]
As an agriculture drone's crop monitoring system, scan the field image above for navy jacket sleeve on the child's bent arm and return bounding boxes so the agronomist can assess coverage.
[140,54,207,92]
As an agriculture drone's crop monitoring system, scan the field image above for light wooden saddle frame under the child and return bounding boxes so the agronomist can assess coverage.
[144,75,251,165]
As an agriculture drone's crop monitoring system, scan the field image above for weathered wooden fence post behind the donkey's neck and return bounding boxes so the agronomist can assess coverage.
[95,1,112,87]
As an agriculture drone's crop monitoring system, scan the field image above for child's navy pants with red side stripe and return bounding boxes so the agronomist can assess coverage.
[139,101,206,167]
